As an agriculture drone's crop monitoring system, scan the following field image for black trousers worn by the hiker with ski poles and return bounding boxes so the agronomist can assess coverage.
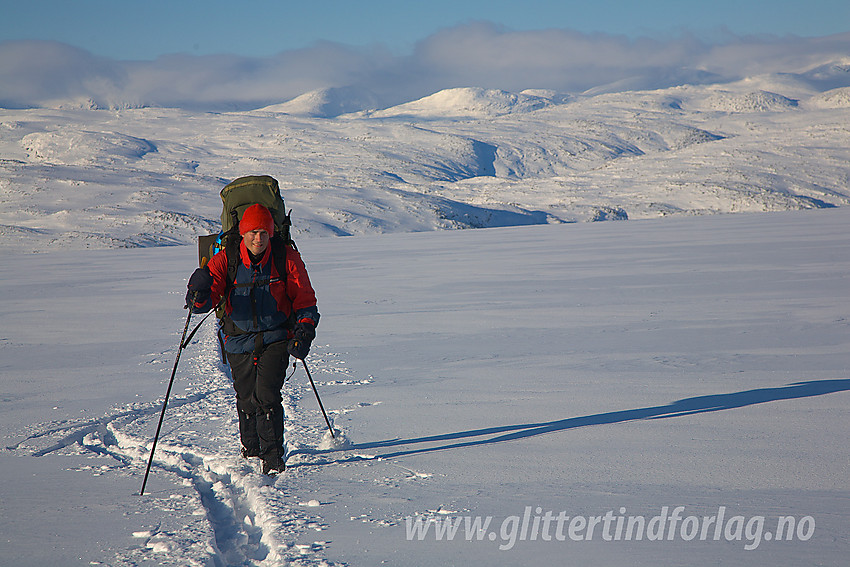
[227,341,289,460]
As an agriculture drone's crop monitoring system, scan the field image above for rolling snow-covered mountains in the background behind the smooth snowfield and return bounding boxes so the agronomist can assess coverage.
[0,60,850,251]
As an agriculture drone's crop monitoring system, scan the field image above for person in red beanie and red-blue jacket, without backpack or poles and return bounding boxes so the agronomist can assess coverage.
[186,204,319,475]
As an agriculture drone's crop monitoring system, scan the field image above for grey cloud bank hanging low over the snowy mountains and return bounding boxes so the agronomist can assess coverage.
[0,22,850,110]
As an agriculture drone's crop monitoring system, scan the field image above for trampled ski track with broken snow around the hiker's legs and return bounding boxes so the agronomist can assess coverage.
[5,324,374,567]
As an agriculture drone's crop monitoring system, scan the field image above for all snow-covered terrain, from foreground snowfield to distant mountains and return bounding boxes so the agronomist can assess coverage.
[0,54,850,567]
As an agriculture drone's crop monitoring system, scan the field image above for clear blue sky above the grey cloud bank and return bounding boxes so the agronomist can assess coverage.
[0,0,850,60]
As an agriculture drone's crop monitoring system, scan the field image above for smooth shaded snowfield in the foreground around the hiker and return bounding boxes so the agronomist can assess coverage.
[0,208,850,566]
